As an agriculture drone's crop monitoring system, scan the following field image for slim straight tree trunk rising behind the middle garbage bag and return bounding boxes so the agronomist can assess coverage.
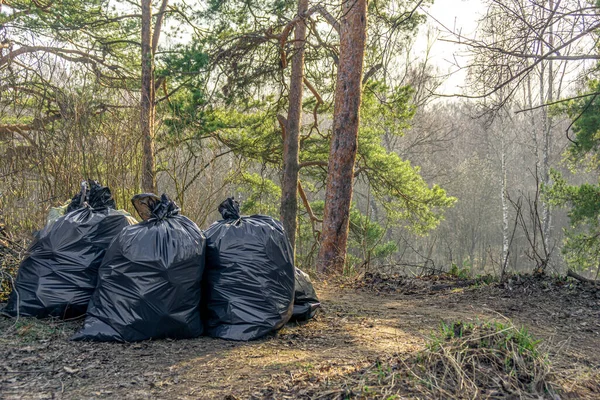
[140,0,156,193]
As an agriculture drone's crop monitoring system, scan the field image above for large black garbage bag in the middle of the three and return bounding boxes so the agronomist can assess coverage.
[72,194,206,342]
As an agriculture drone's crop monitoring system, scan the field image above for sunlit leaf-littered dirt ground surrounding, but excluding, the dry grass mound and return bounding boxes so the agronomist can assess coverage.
[0,276,600,400]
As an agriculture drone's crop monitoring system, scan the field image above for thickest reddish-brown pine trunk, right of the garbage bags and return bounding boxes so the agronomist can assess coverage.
[317,0,367,273]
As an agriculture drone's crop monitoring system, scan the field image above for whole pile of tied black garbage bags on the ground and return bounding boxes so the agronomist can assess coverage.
[3,186,320,342]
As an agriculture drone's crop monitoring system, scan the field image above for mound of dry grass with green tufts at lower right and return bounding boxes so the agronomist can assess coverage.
[412,322,554,399]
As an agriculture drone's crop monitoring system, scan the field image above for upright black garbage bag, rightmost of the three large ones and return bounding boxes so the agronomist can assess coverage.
[204,198,294,340]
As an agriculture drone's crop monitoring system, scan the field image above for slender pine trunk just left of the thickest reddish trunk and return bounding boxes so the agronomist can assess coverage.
[281,0,308,251]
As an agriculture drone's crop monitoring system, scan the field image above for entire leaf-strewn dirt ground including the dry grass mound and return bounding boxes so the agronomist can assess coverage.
[0,282,600,400]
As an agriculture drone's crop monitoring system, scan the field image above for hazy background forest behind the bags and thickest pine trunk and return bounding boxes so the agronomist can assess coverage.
[0,0,600,282]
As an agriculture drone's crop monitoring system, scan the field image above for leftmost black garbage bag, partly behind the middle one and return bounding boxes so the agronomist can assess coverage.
[3,181,136,318]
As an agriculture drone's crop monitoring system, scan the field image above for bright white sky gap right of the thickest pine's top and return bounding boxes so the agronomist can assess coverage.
[415,0,485,94]
